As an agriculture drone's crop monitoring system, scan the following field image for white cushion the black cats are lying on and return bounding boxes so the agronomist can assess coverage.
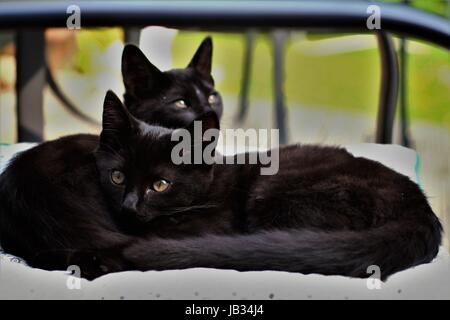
[0,144,450,299]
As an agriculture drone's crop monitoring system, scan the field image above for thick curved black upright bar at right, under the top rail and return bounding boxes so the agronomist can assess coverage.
[375,31,399,144]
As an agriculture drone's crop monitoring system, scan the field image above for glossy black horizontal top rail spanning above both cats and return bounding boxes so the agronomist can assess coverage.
[0,0,450,49]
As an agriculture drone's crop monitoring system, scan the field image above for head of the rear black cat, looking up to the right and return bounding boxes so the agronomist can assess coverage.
[122,37,223,128]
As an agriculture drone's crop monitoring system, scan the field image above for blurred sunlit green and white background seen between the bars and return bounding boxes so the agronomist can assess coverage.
[0,0,450,248]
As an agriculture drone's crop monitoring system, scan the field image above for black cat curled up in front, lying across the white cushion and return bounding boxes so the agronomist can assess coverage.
[0,92,441,279]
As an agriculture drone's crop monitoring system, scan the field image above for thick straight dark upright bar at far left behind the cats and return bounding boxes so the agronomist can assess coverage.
[16,29,45,142]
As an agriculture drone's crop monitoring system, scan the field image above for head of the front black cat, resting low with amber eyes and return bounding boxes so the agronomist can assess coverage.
[95,91,219,223]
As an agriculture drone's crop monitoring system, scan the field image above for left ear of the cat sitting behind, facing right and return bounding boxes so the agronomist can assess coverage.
[122,44,163,98]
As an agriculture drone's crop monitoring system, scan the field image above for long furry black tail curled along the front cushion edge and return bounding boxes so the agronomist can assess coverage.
[124,209,442,280]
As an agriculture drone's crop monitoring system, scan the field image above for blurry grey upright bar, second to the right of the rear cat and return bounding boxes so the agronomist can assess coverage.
[272,30,288,144]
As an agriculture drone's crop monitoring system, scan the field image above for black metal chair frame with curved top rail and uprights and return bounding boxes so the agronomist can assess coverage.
[0,0,450,143]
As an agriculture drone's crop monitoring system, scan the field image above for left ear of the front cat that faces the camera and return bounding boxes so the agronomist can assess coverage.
[100,90,135,144]
